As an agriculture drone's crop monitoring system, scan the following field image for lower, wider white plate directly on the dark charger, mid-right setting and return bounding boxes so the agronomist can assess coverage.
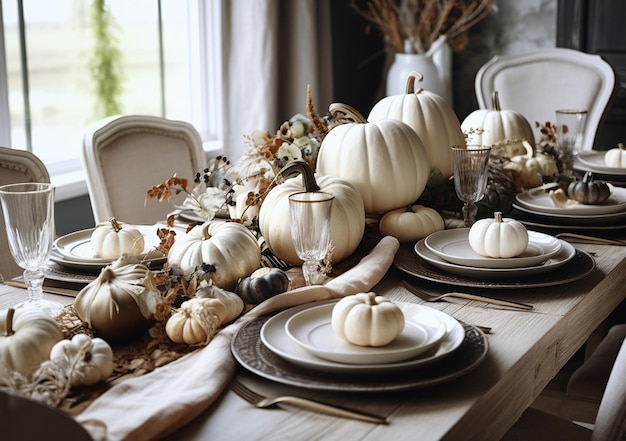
[415,239,576,279]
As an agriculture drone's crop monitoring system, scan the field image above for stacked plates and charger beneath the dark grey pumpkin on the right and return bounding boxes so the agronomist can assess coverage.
[513,183,626,226]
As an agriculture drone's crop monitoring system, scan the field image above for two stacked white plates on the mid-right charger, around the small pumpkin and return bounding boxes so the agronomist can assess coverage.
[415,228,576,279]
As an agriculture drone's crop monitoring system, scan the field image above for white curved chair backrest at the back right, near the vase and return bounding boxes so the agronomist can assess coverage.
[475,48,617,150]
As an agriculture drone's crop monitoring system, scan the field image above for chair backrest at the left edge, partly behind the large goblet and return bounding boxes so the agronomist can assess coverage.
[0,147,50,279]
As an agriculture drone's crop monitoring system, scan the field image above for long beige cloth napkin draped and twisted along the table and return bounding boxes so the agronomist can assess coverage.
[76,236,399,441]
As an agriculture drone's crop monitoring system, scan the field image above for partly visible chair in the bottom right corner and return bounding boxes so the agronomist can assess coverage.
[503,330,626,441]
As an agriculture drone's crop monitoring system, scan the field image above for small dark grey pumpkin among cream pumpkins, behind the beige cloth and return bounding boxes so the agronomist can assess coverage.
[235,267,290,305]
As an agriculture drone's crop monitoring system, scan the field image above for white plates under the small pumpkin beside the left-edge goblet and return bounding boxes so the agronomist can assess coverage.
[50,225,166,272]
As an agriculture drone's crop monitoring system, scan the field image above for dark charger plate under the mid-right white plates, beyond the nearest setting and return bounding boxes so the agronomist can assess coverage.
[393,244,596,289]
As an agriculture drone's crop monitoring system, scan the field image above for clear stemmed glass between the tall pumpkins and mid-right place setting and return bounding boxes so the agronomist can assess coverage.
[452,145,491,227]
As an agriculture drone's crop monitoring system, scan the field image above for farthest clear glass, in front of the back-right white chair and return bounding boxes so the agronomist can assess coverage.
[556,109,587,180]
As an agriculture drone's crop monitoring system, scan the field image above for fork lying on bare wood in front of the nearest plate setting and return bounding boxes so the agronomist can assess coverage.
[230,380,387,424]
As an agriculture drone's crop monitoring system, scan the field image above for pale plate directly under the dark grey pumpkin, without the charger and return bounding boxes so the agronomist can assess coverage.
[515,187,626,216]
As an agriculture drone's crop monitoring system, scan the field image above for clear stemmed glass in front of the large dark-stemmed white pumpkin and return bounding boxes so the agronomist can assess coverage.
[289,191,334,285]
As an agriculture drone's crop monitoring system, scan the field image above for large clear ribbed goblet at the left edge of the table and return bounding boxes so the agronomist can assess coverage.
[0,183,63,317]
